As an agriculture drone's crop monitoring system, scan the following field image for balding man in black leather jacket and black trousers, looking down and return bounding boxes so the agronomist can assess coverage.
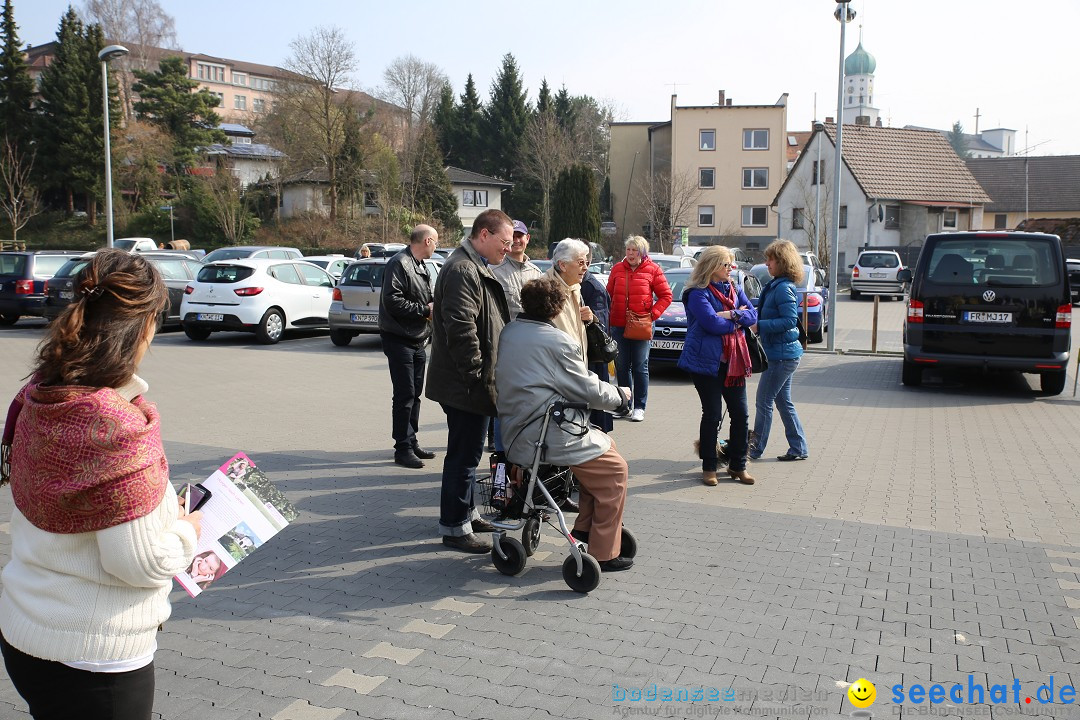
[379,225,438,468]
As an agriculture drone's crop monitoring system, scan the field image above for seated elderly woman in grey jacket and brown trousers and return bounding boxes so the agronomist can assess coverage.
[495,277,634,572]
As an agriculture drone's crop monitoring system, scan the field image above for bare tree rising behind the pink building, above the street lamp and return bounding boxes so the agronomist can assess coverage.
[83,0,180,118]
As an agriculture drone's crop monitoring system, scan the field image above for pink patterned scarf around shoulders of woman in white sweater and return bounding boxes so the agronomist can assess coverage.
[2,381,168,533]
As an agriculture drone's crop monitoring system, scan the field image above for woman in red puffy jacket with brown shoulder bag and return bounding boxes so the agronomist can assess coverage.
[607,235,672,422]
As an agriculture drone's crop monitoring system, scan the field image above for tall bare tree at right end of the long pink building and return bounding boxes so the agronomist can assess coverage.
[279,26,356,220]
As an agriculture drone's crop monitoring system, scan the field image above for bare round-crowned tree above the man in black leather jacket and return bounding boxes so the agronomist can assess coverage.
[376,55,450,207]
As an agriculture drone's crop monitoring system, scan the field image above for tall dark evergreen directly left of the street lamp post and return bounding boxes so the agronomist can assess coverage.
[35,6,117,222]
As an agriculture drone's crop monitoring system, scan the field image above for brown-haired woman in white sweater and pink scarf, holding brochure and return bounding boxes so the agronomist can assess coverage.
[0,249,201,720]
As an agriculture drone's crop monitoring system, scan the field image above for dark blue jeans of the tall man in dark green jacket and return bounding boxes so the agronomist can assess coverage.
[438,405,487,538]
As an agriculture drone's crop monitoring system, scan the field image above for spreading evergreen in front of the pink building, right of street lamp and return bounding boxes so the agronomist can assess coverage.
[132,56,226,172]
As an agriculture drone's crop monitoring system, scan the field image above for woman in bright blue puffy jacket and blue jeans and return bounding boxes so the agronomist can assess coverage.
[750,240,809,462]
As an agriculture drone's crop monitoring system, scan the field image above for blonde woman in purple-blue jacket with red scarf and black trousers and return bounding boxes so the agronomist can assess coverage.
[678,245,757,486]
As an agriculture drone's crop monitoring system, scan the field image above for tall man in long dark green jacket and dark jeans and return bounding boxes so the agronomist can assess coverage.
[427,209,513,553]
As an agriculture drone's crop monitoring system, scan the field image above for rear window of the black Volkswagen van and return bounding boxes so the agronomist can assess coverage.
[927,237,1062,287]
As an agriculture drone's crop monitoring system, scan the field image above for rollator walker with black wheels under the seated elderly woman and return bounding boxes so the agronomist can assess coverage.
[476,400,637,593]
